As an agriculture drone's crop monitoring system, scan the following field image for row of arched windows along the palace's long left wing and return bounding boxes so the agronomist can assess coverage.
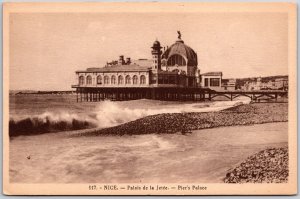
[79,75,146,85]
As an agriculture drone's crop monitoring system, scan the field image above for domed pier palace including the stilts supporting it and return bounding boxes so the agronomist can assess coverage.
[72,31,222,101]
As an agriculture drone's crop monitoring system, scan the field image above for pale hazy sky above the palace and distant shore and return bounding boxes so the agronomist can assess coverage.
[10,13,288,90]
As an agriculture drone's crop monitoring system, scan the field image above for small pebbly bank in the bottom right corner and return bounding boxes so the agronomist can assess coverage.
[224,147,289,183]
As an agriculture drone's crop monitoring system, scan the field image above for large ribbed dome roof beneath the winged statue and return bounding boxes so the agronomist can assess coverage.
[162,39,198,66]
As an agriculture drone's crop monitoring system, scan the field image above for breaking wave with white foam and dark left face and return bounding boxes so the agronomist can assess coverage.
[9,100,248,136]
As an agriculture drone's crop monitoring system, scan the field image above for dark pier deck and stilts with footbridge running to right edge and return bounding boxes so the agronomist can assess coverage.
[72,86,288,102]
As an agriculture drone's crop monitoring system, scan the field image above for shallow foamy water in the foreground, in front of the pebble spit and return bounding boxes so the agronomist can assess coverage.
[9,122,288,183]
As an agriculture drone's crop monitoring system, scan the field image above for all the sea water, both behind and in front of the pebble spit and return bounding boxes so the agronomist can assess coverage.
[9,95,288,183]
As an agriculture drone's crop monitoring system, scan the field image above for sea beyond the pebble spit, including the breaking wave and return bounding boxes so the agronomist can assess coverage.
[9,95,249,134]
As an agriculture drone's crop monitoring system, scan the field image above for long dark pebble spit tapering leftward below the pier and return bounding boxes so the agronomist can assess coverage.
[80,103,288,136]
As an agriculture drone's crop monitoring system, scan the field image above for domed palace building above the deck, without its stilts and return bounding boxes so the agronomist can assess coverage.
[73,35,200,88]
